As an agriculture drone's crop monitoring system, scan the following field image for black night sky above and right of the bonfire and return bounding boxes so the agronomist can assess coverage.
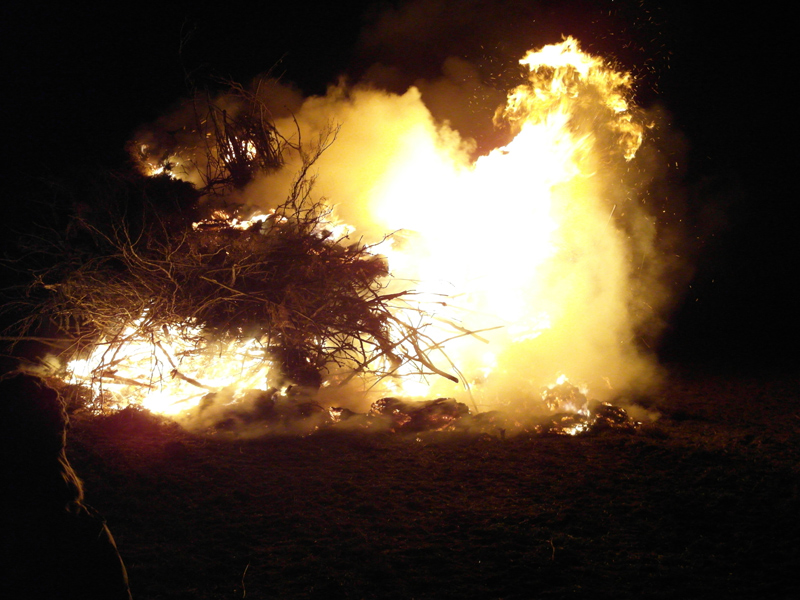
[0,0,800,370]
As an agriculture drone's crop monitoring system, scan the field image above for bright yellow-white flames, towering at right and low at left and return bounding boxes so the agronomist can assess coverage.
[64,38,655,420]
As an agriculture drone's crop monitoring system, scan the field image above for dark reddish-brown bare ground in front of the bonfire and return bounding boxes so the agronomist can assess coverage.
[67,373,800,600]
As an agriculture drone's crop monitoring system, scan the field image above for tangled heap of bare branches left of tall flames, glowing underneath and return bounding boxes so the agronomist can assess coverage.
[0,88,454,422]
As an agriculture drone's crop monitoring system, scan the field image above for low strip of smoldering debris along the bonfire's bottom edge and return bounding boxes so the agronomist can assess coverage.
[159,383,641,439]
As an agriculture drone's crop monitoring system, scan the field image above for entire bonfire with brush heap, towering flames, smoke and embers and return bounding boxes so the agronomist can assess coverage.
[4,38,663,435]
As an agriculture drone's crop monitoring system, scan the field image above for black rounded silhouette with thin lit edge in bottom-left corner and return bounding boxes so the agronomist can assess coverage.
[0,375,131,600]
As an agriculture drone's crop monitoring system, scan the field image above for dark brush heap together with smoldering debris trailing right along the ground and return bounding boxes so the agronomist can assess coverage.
[1,169,637,436]
